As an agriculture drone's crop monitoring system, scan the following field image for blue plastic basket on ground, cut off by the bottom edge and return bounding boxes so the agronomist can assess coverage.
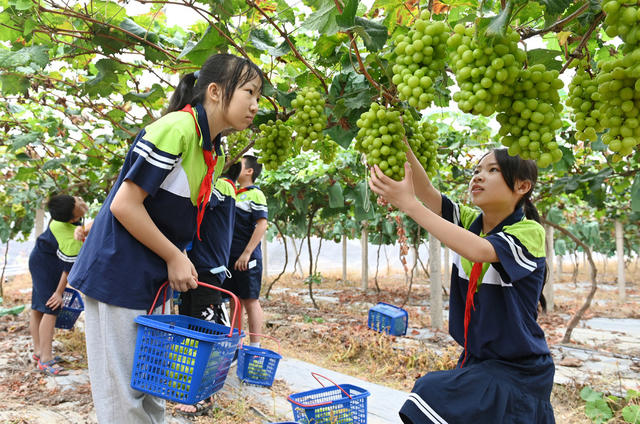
[287,373,370,424]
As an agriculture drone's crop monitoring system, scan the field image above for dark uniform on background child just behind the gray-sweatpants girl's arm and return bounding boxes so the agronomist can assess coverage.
[180,178,236,319]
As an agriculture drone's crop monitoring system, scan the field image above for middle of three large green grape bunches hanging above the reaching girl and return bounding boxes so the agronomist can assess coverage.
[447,24,526,116]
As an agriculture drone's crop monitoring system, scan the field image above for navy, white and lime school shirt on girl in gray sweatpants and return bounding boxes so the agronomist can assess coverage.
[69,104,225,310]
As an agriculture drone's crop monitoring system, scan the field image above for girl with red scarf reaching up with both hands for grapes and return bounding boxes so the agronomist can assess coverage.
[369,149,555,424]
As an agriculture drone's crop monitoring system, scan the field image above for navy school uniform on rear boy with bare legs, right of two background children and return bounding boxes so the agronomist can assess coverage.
[223,185,268,299]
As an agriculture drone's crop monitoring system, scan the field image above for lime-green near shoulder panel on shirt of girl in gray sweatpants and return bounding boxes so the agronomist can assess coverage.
[143,111,198,155]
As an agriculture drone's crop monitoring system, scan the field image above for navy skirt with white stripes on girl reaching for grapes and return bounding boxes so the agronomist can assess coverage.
[400,355,555,424]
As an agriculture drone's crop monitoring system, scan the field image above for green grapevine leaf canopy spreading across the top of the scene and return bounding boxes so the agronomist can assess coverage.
[0,0,640,262]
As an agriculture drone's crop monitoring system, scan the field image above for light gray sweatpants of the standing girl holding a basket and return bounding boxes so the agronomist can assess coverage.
[83,296,170,424]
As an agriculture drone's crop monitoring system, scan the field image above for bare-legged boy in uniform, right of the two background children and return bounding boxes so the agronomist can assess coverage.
[223,155,267,347]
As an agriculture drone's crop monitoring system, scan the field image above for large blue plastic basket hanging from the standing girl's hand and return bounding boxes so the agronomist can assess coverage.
[131,315,244,405]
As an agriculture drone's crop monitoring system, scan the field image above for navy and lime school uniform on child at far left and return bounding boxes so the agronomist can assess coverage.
[29,219,82,315]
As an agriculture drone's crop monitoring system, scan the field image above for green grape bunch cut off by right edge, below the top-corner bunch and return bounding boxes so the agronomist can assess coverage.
[596,56,640,162]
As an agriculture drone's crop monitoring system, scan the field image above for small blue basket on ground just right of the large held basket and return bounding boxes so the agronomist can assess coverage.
[236,345,282,387]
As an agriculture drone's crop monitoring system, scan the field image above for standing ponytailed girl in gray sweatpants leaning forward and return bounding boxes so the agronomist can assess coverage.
[69,54,262,423]
